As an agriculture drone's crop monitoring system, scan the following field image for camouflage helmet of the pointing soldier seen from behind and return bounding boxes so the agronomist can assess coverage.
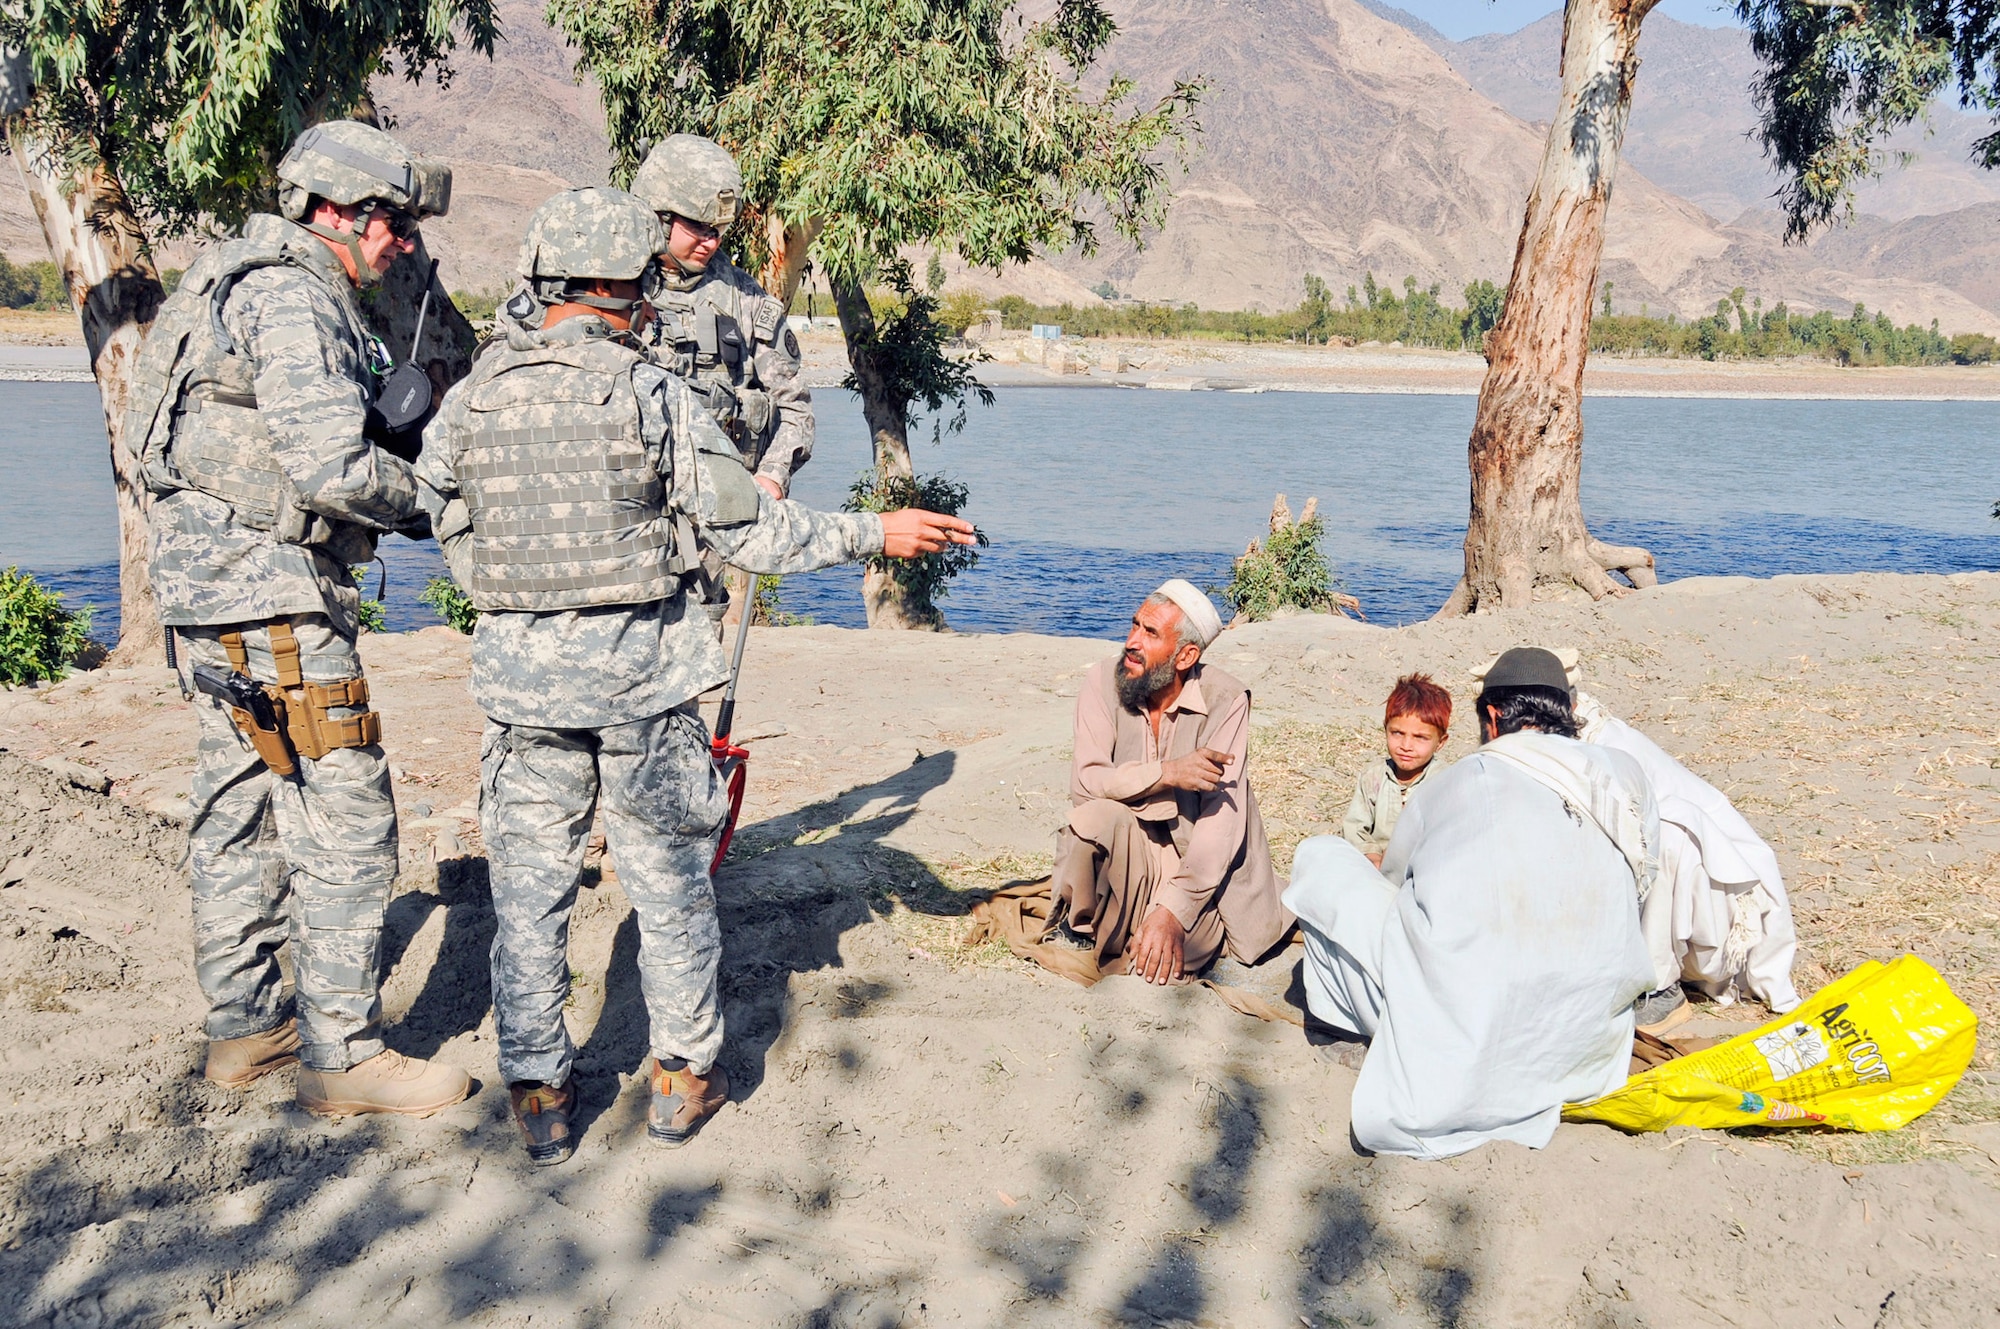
[520,186,666,314]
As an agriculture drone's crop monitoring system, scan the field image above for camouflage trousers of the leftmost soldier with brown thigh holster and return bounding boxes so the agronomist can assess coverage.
[180,614,398,1071]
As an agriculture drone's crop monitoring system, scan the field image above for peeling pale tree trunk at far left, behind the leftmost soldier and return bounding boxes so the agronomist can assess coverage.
[8,130,166,665]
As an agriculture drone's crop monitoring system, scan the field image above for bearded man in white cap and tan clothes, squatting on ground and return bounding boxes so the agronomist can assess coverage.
[1050,578,1292,983]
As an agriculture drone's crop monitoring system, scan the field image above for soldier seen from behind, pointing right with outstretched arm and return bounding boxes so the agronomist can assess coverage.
[416,188,972,1165]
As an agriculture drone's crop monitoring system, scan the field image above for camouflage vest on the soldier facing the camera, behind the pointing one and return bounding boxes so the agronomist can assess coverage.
[650,254,784,456]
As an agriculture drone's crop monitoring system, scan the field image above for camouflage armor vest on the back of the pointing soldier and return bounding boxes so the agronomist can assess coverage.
[454,338,692,612]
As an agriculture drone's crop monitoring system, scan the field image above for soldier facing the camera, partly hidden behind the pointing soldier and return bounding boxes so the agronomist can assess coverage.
[632,134,812,498]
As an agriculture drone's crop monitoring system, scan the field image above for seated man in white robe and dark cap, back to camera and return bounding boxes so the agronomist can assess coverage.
[1284,648,1660,1159]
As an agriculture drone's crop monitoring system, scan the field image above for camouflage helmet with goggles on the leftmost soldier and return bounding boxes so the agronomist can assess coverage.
[278,120,452,286]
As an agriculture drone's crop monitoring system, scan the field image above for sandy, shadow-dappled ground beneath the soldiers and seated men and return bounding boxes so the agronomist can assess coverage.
[0,574,2000,1329]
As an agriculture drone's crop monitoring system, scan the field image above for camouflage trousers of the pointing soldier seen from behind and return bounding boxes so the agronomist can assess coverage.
[480,703,728,1085]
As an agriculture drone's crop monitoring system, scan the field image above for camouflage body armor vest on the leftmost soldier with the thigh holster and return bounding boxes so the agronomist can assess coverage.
[126,216,370,544]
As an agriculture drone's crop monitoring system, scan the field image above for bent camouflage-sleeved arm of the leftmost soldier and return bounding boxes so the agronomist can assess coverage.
[224,268,420,530]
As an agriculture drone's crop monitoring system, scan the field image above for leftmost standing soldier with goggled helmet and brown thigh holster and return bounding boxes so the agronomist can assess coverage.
[126,122,470,1115]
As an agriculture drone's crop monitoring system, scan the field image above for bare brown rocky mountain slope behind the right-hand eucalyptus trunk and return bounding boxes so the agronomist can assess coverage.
[1056,0,2000,330]
